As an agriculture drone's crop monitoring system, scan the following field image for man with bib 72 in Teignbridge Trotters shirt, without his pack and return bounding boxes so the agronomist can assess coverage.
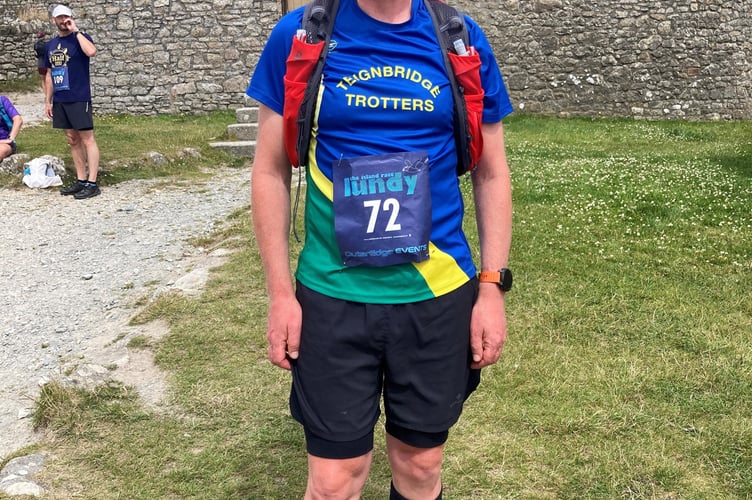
[247,0,512,499]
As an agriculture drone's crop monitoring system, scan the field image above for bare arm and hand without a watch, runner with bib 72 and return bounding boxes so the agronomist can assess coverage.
[251,104,302,370]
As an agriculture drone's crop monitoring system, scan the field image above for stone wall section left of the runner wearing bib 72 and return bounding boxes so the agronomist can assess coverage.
[0,0,280,114]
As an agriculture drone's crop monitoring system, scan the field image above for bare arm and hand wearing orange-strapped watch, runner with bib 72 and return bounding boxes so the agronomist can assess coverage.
[470,122,512,368]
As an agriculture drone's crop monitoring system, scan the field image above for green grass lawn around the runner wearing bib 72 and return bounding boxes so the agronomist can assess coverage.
[2,115,752,499]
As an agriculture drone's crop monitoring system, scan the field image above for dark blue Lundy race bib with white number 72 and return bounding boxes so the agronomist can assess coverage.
[333,151,431,267]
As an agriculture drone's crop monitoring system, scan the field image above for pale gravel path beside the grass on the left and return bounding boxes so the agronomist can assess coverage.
[0,93,250,459]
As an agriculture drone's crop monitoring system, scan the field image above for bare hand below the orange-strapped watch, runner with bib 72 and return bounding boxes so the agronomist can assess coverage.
[470,283,507,368]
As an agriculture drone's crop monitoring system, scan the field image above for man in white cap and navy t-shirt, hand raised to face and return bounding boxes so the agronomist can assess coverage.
[45,5,100,200]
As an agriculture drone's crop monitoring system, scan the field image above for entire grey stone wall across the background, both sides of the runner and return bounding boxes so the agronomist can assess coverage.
[0,0,752,119]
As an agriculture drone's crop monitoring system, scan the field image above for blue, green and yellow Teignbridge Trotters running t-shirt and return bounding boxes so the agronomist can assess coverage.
[247,0,512,303]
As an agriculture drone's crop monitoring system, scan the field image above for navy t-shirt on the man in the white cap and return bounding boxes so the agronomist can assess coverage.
[45,33,92,102]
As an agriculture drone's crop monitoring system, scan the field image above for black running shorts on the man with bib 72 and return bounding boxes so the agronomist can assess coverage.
[290,280,480,458]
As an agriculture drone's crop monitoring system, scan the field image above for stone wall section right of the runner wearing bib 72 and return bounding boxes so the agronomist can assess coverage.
[452,0,752,119]
